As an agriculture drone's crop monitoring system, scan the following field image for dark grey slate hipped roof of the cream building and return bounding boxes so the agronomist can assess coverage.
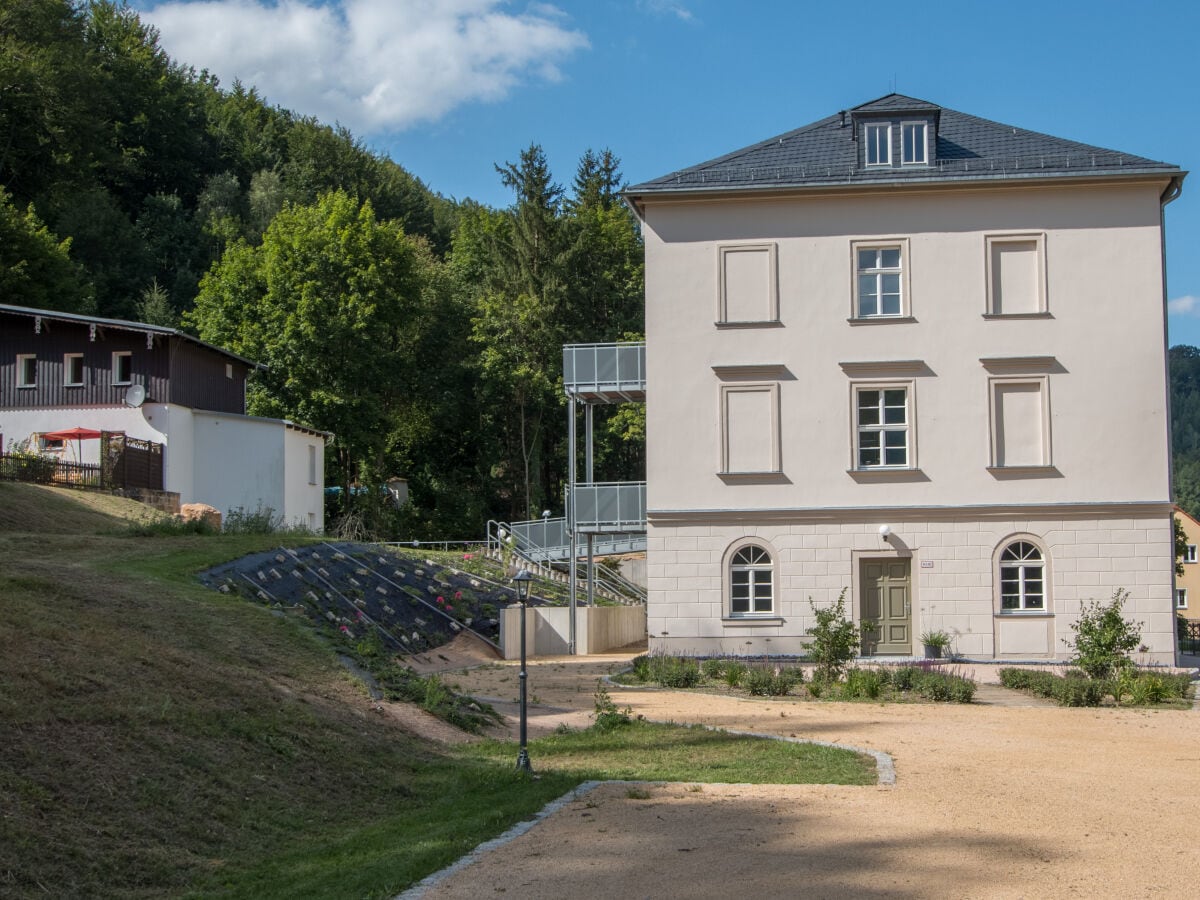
[625,94,1186,198]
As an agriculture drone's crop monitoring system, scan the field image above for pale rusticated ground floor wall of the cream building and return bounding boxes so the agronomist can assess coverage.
[647,504,1175,665]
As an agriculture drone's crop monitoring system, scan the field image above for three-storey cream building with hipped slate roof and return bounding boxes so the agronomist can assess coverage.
[626,94,1186,664]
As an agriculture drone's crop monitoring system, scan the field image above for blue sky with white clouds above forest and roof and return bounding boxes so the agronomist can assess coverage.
[133,0,1200,346]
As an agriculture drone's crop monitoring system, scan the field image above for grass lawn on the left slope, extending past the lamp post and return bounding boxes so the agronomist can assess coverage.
[0,482,872,898]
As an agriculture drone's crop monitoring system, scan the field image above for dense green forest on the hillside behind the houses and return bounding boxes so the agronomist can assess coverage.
[0,0,644,538]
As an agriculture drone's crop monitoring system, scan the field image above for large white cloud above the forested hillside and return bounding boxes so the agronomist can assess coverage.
[140,0,588,132]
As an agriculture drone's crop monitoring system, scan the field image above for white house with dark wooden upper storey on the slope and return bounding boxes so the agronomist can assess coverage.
[0,304,329,533]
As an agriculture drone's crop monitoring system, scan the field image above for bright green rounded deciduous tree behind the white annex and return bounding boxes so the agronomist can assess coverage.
[191,191,436,504]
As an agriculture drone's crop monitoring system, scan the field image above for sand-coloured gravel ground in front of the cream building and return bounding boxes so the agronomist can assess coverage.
[408,656,1200,900]
